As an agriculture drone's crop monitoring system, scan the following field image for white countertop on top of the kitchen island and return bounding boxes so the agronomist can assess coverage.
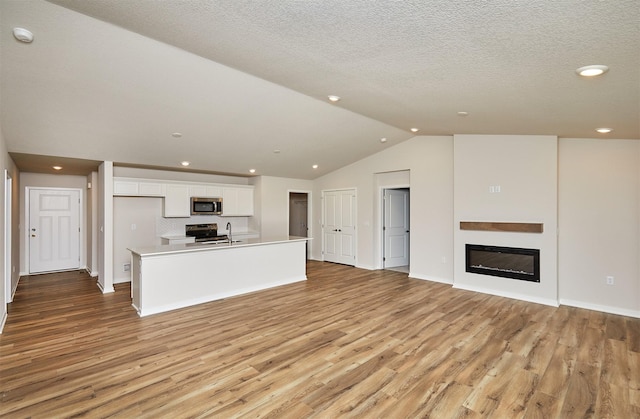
[127,236,311,257]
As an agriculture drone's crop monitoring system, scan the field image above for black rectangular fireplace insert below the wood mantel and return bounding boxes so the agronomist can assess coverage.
[466,244,540,282]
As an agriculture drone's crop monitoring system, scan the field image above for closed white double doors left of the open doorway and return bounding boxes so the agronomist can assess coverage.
[323,189,356,265]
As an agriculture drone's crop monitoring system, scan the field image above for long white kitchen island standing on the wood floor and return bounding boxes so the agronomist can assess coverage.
[128,237,309,317]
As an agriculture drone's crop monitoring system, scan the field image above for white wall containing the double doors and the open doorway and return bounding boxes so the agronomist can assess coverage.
[312,136,453,283]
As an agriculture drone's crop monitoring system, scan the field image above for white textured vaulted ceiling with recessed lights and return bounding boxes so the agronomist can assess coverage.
[0,0,640,178]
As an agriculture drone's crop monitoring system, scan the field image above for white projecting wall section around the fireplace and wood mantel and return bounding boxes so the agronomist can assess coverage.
[453,135,558,305]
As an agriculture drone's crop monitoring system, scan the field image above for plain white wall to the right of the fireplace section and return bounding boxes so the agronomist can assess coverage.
[558,139,640,317]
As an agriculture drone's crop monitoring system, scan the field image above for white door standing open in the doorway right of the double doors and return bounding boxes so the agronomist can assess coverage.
[383,189,409,268]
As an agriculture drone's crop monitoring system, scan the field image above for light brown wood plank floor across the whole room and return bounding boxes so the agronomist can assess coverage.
[0,262,640,418]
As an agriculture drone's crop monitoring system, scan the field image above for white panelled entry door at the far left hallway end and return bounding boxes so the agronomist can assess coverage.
[29,189,80,273]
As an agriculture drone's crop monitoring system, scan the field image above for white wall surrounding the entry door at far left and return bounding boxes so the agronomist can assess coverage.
[19,172,88,275]
